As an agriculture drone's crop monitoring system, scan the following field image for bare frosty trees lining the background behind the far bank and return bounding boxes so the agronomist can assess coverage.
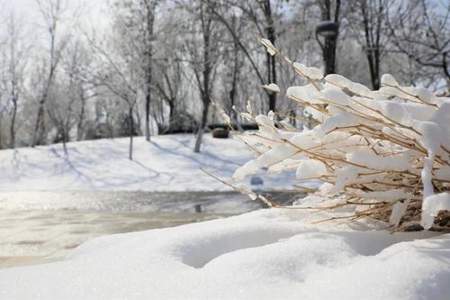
[0,0,450,159]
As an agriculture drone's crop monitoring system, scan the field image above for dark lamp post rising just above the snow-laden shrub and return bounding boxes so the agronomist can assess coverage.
[316,21,339,75]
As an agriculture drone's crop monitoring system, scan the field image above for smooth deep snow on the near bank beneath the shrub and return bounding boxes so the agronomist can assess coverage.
[0,209,450,300]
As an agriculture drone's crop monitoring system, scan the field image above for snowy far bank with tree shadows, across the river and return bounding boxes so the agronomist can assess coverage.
[0,135,294,191]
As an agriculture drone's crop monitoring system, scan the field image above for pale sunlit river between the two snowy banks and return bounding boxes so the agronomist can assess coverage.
[0,192,295,268]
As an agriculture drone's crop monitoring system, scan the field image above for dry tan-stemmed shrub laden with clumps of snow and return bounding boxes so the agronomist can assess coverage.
[234,40,450,229]
